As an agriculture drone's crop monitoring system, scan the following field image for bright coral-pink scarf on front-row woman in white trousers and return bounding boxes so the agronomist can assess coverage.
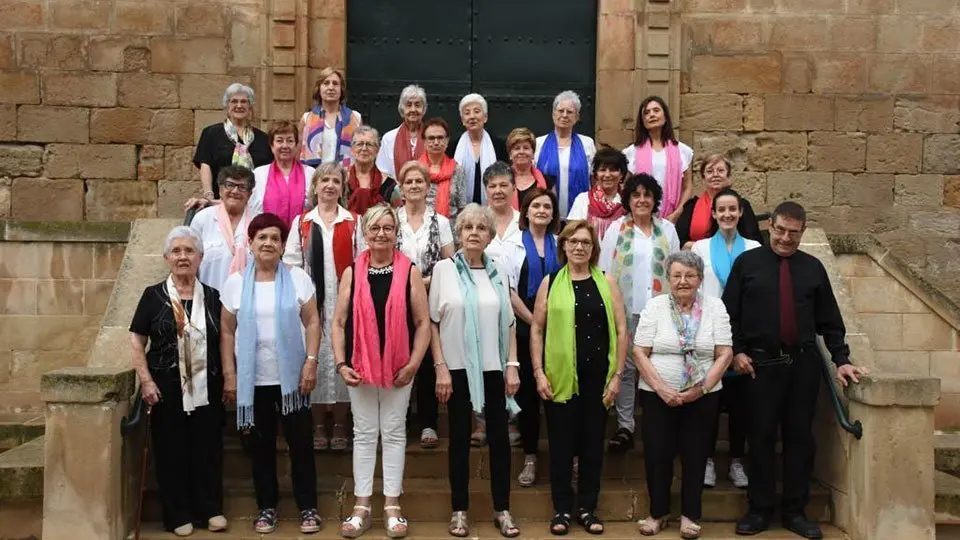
[353,249,412,388]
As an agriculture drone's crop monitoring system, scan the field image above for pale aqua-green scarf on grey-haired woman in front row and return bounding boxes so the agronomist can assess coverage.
[453,250,520,414]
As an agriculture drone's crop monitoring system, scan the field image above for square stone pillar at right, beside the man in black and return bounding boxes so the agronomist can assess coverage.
[846,373,940,540]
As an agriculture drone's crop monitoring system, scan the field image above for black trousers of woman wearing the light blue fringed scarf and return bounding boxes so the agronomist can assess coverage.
[243,385,317,512]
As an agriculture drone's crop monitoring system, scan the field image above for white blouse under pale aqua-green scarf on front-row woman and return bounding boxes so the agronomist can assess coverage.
[430,259,515,371]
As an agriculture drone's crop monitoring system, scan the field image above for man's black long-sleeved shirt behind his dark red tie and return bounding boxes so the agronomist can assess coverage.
[723,246,850,366]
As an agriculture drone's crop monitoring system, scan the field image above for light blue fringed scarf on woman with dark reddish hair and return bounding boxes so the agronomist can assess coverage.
[237,261,310,429]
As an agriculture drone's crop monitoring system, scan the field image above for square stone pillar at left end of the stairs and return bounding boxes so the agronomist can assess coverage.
[40,367,134,540]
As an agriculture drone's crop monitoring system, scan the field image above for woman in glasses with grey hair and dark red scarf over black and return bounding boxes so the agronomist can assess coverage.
[344,126,401,215]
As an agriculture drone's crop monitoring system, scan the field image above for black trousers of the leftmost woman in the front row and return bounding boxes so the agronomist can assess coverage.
[150,370,224,531]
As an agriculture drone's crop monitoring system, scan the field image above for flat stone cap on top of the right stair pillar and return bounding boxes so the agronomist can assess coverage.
[846,373,940,407]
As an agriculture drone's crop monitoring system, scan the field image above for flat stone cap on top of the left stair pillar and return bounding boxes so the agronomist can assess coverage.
[40,367,134,403]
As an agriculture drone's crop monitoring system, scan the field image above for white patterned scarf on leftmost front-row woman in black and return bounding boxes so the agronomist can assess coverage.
[167,275,210,414]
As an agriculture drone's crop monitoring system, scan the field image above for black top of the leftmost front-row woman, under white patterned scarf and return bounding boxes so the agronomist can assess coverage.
[130,280,220,378]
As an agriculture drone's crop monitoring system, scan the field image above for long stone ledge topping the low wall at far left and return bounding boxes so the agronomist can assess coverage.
[0,219,131,242]
